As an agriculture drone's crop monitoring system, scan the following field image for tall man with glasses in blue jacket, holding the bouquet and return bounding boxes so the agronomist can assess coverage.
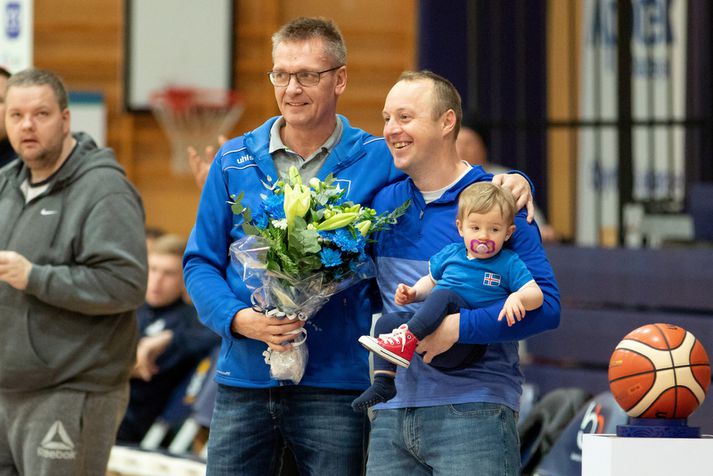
[184,14,536,476]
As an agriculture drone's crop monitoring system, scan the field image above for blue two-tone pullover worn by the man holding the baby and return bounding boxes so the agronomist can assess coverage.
[373,166,560,410]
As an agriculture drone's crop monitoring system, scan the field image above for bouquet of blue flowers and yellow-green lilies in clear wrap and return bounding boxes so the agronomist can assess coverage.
[230,167,410,383]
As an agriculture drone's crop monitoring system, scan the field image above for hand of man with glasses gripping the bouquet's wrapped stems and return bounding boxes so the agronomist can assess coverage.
[230,308,305,352]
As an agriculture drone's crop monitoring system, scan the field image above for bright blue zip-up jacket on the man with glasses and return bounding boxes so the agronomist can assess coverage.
[184,116,403,390]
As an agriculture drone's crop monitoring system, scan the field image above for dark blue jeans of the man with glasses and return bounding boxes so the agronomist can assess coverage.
[206,385,368,476]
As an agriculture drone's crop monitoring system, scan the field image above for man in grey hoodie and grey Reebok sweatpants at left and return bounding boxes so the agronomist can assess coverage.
[0,69,146,475]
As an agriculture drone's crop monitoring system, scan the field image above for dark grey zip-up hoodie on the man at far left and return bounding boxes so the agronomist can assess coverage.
[0,133,147,392]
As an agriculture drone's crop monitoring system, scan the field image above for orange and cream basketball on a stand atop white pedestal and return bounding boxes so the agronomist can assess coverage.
[609,324,711,418]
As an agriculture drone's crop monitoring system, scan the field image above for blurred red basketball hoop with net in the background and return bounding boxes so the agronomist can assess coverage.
[150,86,245,174]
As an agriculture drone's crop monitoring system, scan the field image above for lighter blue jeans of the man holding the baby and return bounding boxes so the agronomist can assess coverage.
[366,403,520,476]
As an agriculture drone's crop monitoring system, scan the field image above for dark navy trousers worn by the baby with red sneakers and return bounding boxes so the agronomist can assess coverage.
[374,289,488,370]
